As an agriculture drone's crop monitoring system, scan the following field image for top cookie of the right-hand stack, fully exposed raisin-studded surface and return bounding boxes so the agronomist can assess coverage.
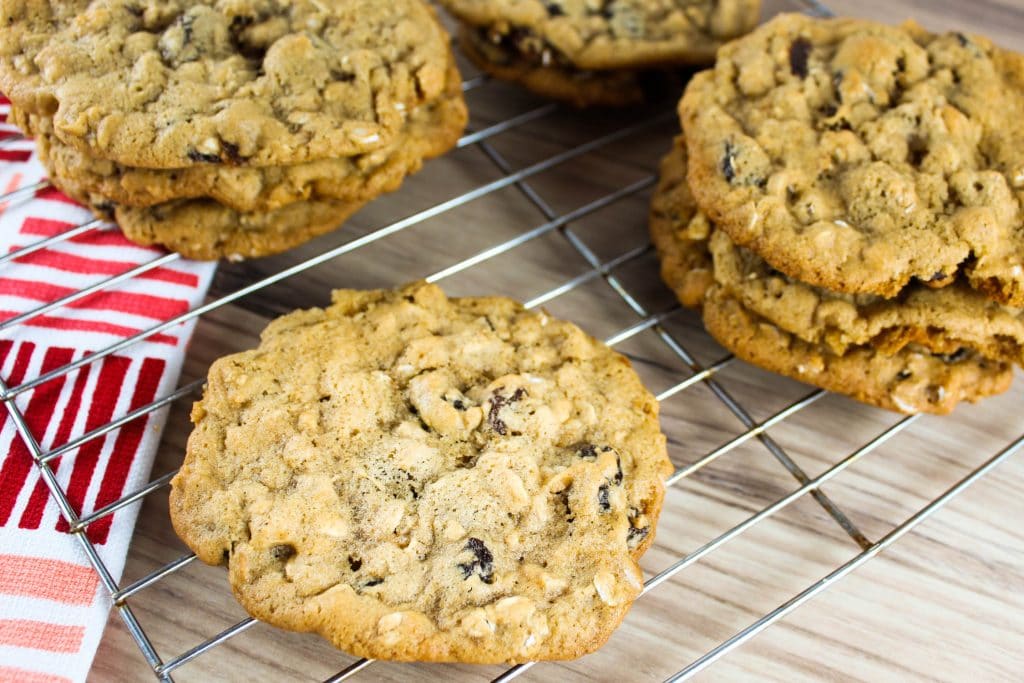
[680,14,1024,306]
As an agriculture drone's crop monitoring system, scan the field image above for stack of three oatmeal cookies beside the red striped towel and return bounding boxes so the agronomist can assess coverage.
[0,0,466,259]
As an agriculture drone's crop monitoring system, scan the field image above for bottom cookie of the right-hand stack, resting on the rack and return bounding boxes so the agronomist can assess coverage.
[703,286,1014,415]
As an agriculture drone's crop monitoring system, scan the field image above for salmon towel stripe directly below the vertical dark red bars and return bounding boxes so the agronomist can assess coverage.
[0,555,99,605]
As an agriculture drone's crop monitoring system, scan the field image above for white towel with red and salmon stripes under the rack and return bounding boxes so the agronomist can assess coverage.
[0,100,214,683]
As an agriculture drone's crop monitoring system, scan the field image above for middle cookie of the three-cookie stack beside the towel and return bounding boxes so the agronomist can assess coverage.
[18,63,467,212]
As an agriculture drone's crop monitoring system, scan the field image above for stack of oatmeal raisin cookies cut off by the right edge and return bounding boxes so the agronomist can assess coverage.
[651,15,1024,413]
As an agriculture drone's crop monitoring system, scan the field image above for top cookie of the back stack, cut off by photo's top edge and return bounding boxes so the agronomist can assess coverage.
[441,0,761,71]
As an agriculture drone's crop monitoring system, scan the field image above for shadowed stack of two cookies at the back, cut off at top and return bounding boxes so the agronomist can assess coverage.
[441,0,761,106]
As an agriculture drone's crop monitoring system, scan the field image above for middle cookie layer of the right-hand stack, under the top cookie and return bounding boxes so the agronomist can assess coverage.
[651,136,1024,366]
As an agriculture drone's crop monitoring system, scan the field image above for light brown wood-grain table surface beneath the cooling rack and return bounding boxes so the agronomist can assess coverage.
[90,0,1024,682]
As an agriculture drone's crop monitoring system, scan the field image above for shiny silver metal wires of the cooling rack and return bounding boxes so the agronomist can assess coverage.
[0,0,1024,682]
